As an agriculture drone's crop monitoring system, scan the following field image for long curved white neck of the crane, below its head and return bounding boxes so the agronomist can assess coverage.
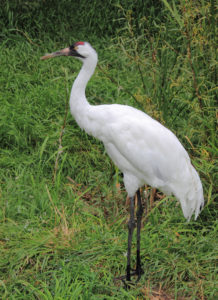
[70,53,98,118]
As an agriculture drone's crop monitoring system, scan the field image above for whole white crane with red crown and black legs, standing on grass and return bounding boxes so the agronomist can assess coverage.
[41,42,204,281]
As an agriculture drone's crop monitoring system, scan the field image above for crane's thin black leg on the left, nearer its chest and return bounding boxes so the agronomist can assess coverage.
[126,197,135,281]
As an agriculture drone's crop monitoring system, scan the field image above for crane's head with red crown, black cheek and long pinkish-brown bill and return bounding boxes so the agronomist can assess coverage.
[41,42,97,62]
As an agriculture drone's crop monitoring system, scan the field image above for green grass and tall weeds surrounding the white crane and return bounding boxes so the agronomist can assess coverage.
[0,0,218,300]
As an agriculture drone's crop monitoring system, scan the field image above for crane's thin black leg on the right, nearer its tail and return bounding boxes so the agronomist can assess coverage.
[136,190,143,281]
